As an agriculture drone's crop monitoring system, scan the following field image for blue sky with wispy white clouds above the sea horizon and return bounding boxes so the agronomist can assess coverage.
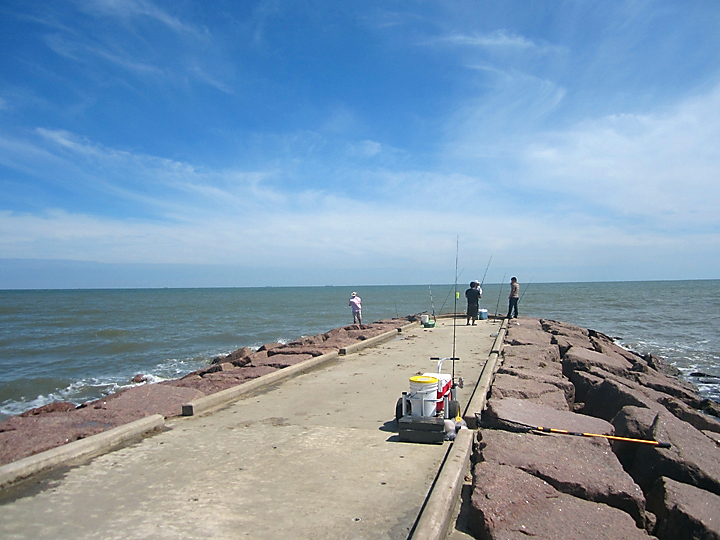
[0,0,720,289]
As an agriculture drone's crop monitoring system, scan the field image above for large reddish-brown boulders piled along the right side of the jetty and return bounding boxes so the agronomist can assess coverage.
[468,317,720,540]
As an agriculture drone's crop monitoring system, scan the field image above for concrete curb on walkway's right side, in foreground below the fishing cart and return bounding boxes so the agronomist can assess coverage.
[412,429,474,540]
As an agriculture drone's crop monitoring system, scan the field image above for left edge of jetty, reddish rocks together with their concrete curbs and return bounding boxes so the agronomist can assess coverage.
[0,315,420,490]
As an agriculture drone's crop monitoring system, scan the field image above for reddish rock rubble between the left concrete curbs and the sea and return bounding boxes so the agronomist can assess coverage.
[0,316,416,465]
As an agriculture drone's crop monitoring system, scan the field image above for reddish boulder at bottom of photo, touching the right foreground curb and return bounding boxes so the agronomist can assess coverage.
[469,462,648,540]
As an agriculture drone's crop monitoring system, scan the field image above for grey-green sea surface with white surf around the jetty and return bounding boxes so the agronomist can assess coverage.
[0,280,720,419]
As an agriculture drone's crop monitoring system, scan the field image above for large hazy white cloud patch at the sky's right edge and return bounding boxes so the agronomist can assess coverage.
[519,87,720,230]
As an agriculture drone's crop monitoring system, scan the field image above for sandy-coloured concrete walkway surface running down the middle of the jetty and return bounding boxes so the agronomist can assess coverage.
[0,319,499,540]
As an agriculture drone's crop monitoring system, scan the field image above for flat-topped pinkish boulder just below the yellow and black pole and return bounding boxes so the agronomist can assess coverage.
[480,430,645,528]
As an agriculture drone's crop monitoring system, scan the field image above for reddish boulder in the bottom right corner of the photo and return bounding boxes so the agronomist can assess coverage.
[647,477,720,540]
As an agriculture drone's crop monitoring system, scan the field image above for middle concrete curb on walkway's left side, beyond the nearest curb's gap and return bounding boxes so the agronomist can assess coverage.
[182,351,338,416]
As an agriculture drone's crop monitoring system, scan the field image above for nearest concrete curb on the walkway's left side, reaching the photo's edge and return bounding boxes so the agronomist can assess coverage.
[0,414,165,489]
